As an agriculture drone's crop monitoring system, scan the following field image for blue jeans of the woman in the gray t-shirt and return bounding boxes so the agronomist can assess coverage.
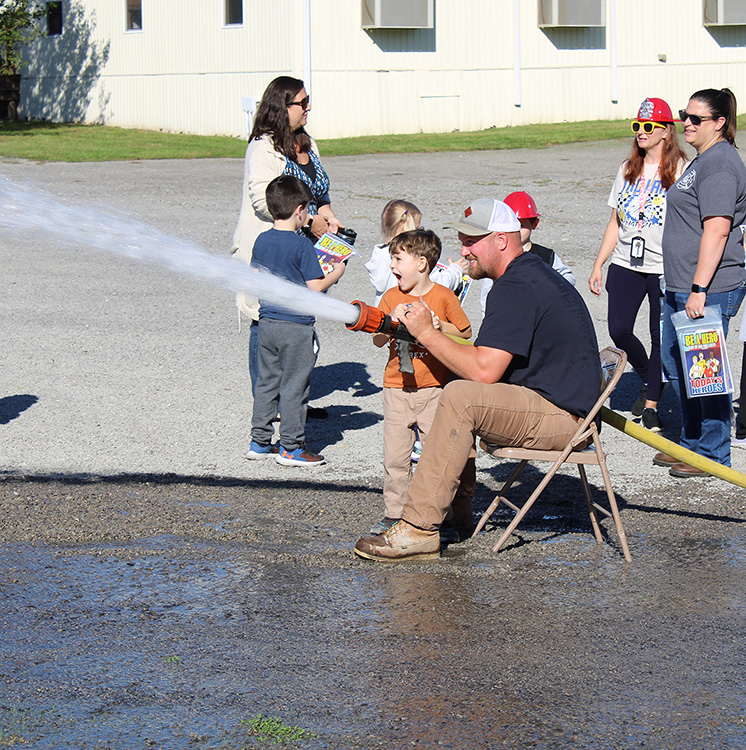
[661,284,746,466]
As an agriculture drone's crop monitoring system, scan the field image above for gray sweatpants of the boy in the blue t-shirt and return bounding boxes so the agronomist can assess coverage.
[251,318,317,451]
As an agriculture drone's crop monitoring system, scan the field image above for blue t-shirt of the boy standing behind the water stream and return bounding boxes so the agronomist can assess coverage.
[251,228,324,325]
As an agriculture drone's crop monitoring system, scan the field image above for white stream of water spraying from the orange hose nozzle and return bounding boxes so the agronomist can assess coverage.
[0,177,359,323]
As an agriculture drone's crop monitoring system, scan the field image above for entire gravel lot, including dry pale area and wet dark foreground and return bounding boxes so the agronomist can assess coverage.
[0,142,746,750]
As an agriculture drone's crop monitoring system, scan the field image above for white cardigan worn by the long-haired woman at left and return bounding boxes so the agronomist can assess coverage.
[231,134,319,320]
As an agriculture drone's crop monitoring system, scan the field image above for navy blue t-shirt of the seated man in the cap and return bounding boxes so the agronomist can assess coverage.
[474,253,601,417]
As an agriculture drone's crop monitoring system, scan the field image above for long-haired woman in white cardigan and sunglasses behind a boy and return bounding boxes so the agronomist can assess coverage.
[231,76,344,402]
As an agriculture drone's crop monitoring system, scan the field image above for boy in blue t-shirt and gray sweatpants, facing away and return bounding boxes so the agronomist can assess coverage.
[247,175,345,466]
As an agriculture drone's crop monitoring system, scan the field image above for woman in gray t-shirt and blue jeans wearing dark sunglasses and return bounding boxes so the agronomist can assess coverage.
[653,89,746,478]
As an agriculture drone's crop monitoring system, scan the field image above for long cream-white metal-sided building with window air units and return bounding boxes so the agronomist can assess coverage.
[20,0,746,138]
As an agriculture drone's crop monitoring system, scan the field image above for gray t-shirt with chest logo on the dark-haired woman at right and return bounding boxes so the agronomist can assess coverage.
[663,141,746,293]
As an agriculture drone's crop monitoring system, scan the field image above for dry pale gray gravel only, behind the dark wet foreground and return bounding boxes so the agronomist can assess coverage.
[0,142,746,494]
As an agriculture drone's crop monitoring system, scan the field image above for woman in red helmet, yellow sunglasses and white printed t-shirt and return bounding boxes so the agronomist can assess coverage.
[588,97,686,432]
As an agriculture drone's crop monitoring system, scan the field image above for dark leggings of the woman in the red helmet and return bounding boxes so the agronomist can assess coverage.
[606,263,661,402]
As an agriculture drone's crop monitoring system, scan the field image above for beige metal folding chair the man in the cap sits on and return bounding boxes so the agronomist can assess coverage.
[474,346,632,562]
